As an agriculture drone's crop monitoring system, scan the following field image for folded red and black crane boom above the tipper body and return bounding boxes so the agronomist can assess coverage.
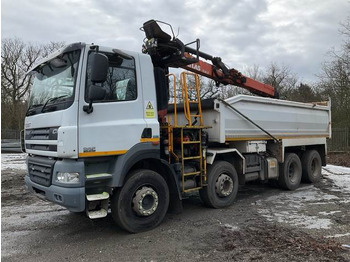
[142,20,278,98]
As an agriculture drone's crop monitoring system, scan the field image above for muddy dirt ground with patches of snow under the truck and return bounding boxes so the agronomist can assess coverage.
[1,154,350,262]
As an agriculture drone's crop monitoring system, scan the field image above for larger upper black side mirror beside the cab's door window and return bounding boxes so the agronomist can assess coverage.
[90,53,109,83]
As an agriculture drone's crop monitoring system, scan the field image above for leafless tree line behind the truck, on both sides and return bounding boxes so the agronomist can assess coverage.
[1,17,350,133]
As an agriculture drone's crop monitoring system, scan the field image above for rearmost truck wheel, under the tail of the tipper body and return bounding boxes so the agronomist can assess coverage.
[301,150,322,183]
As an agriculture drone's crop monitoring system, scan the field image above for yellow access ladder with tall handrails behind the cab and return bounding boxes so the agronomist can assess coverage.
[163,72,207,192]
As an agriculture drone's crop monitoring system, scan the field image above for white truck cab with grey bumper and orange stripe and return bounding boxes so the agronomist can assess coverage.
[24,43,170,223]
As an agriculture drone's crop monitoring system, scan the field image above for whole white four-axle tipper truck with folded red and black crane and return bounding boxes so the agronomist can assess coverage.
[22,20,331,233]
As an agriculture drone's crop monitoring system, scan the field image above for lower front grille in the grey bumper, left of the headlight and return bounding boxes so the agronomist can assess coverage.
[28,157,56,186]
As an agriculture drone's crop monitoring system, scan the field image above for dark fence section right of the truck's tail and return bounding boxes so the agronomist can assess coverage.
[327,127,350,152]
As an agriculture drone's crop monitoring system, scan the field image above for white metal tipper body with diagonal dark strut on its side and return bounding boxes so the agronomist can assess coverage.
[197,95,331,143]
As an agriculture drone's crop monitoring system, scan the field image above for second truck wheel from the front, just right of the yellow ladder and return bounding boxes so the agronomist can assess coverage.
[199,161,238,208]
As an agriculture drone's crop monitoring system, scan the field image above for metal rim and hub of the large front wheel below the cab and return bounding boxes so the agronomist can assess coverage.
[132,186,158,216]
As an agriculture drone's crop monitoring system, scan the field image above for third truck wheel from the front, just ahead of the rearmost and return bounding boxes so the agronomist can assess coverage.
[278,153,302,190]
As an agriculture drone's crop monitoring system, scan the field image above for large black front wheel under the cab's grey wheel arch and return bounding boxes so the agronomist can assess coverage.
[111,169,169,233]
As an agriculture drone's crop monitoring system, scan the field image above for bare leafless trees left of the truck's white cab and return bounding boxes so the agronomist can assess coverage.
[1,38,63,130]
